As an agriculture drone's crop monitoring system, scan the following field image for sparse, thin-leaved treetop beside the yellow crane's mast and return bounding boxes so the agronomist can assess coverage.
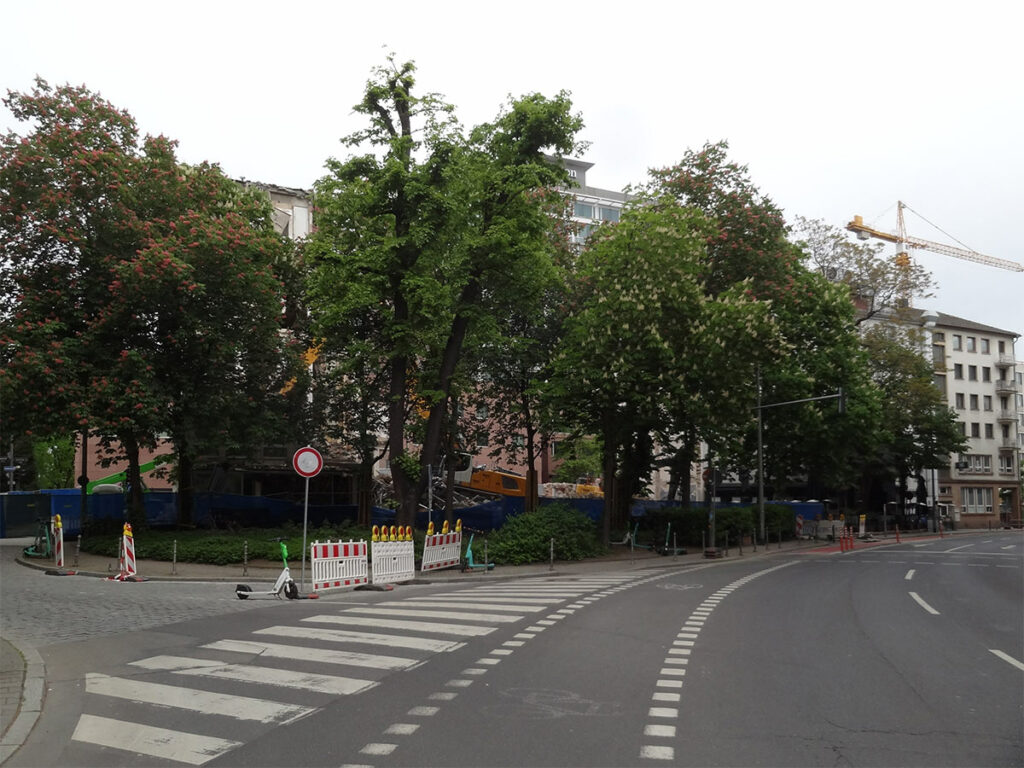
[793,216,935,326]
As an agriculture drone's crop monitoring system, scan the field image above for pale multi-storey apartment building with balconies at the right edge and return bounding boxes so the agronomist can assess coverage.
[922,312,1024,527]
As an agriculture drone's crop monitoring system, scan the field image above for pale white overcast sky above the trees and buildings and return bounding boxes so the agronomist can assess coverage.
[0,0,1024,339]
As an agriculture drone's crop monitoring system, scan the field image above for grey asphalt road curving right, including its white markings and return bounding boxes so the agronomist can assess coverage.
[0,531,1024,768]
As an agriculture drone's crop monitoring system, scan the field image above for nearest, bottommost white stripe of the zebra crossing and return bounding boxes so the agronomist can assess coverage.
[71,715,242,765]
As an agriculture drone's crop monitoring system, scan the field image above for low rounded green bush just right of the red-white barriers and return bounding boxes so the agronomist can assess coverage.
[483,504,605,565]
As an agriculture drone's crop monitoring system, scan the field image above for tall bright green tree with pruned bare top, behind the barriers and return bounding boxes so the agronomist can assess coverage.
[310,59,580,524]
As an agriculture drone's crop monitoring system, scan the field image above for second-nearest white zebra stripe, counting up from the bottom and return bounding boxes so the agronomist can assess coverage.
[85,672,316,725]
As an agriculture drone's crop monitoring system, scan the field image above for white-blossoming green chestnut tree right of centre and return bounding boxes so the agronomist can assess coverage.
[549,199,774,539]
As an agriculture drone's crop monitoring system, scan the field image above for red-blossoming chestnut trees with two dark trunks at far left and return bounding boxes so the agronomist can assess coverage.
[0,81,294,524]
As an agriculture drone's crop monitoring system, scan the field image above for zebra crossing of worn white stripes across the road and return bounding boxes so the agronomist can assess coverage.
[68,574,647,766]
